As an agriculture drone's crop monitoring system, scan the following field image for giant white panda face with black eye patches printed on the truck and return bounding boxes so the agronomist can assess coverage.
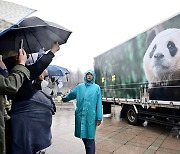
[143,28,180,100]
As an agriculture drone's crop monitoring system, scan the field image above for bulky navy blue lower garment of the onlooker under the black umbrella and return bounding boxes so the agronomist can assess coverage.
[10,90,53,154]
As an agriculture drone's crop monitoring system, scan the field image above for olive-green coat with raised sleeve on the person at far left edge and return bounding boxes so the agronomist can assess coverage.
[0,65,30,154]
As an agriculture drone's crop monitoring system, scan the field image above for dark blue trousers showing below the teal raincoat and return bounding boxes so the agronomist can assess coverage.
[82,138,95,154]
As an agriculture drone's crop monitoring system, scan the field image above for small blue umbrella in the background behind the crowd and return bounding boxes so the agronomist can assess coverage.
[47,65,70,76]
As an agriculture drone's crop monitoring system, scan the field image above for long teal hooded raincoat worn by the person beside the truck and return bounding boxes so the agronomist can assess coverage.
[62,70,102,139]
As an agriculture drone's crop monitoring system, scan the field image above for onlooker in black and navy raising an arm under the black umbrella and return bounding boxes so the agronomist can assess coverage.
[3,42,60,154]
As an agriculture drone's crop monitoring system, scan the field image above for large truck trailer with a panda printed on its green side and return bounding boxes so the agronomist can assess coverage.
[94,14,180,129]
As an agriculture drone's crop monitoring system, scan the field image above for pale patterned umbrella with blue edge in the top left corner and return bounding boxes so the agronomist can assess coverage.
[0,0,36,35]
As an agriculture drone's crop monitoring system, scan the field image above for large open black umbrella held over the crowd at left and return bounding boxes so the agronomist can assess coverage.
[0,17,71,53]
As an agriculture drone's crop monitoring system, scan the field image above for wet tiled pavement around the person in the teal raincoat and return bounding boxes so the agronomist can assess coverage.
[46,103,180,154]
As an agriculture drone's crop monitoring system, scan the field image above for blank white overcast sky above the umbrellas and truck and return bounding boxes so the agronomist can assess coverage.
[7,0,180,72]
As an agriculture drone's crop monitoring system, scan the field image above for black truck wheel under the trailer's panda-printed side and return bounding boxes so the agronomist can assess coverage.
[126,106,139,125]
